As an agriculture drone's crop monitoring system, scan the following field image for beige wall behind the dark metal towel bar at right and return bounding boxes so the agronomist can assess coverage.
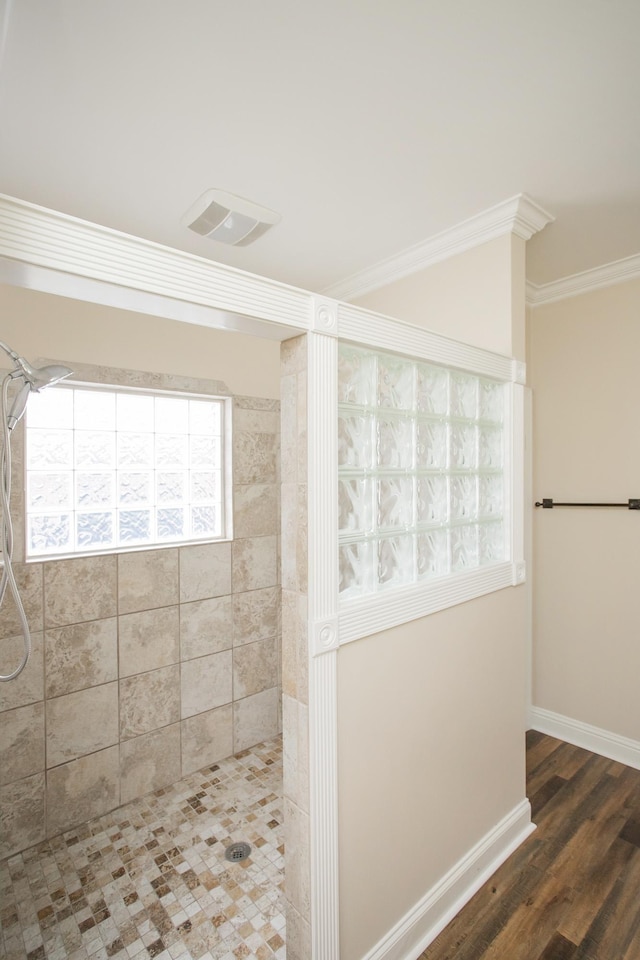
[528,280,640,740]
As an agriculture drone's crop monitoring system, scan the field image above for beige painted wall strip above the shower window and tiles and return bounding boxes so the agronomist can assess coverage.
[0,285,280,400]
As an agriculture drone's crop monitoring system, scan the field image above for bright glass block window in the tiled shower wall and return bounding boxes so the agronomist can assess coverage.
[26,385,225,557]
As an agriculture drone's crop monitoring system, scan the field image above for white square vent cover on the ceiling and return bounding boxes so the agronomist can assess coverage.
[182,190,281,247]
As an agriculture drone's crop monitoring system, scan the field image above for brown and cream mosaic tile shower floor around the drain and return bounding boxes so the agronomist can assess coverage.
[0,738,285,960]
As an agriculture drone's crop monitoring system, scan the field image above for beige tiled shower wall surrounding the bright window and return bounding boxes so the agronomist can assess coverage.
[0,380,281,858]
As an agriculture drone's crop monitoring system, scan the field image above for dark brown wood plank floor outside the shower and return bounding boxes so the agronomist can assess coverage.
[418,732,640,960]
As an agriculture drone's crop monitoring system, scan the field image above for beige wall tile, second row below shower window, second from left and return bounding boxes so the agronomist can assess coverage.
[45,617,118,697]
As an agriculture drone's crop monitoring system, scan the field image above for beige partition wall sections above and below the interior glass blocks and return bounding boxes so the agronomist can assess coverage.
[338,238,527,960]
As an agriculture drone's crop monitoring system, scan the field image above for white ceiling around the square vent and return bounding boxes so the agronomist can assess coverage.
[0,0,640,290]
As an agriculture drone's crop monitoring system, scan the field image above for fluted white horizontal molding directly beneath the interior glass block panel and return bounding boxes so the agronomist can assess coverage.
[339,563,514,645]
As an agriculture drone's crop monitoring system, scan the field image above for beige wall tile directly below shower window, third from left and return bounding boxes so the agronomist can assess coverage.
[118,547,178,614]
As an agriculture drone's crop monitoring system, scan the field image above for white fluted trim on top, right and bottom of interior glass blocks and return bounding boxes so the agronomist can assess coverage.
[336,304,526,645]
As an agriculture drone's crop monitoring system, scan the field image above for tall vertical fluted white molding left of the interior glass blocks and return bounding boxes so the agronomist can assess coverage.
[307,333,340,960]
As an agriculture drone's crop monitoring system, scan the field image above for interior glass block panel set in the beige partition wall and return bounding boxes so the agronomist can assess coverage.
[338,344,507,599]
